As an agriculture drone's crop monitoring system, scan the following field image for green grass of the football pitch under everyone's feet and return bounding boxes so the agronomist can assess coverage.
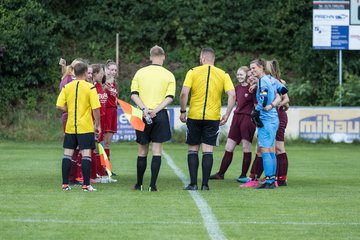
[0,142,360,240]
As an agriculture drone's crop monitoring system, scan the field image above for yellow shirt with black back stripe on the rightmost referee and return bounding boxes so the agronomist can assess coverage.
[183,64,234,120]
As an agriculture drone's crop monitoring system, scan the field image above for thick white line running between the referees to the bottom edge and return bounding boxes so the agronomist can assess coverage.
[163,151,226,239]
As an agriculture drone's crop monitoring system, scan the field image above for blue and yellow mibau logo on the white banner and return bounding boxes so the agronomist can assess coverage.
[299,115,360,142]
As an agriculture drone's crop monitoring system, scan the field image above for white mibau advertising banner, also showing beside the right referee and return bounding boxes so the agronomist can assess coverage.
[174,107,360,143]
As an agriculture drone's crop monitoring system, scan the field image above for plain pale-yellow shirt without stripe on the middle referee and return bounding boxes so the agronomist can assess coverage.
[131,64,176,109]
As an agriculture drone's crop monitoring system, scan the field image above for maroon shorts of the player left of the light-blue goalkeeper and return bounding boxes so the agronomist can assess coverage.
[228,114,256,144]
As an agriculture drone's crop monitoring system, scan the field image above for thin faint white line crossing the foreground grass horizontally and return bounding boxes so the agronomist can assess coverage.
[0,218,360,226]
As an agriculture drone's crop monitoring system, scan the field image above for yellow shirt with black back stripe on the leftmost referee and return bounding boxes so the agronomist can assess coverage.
[56,80,101,134]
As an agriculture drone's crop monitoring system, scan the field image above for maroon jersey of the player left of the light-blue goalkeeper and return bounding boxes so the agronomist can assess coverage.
[234,84,257,115]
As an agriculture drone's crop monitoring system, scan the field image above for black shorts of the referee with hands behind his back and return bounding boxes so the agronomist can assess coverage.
[136,109,171,145]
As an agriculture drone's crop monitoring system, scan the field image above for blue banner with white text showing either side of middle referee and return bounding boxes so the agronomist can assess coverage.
[112,107,175,142]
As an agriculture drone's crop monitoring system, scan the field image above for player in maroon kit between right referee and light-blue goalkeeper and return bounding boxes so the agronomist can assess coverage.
[210,66,256,182]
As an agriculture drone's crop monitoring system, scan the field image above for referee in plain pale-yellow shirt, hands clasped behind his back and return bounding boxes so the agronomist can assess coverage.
[131,45,175,192]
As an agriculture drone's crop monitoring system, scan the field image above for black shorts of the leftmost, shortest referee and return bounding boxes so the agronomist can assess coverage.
[63,133,95,150]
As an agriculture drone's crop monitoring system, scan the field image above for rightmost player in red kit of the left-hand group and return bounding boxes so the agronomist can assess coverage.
[104,60,118,176]
